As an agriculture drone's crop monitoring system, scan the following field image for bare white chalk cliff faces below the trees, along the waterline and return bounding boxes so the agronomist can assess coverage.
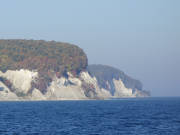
[0,69,147,101]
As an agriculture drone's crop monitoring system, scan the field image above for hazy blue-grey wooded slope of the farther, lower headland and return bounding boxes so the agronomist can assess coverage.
[87,65,149,96]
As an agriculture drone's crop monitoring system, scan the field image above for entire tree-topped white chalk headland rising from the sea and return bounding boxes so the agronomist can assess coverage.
[0,40,148,100]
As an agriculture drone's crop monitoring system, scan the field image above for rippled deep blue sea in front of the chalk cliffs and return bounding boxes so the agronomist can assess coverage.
[0,98,180,135]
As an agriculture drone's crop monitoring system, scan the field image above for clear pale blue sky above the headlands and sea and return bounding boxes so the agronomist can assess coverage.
[0,0,180,96]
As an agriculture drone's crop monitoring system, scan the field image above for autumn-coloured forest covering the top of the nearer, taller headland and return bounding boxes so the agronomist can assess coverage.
[0,40,88,91]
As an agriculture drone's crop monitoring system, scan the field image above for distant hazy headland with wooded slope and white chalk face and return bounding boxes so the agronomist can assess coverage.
[87,65,150,98]
